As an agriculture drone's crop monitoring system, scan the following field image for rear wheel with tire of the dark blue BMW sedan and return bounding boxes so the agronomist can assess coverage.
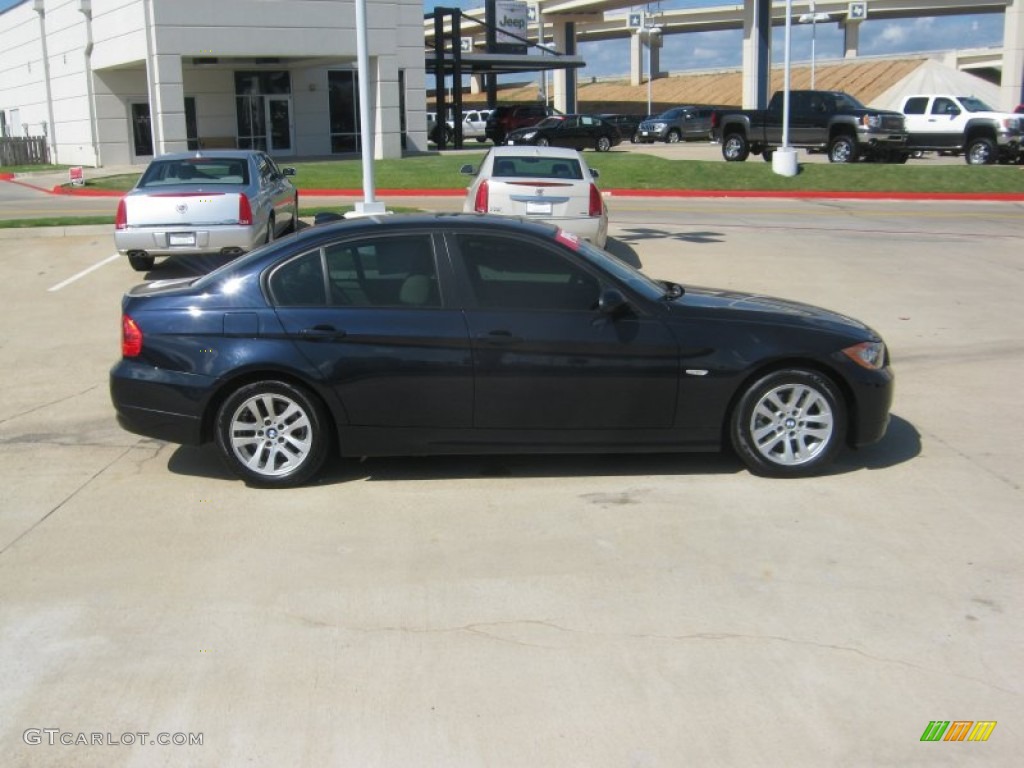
[216,380,331,487]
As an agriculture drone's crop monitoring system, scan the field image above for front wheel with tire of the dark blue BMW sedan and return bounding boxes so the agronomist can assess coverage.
[729,369,847,477]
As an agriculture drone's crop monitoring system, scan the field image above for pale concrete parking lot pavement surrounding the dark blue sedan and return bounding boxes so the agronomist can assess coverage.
[0,201,1024,768]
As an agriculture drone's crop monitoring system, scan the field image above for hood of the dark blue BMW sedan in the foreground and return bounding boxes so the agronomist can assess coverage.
[671,287,877,337]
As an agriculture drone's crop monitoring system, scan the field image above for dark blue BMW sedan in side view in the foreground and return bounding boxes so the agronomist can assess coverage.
[111,214,893,486]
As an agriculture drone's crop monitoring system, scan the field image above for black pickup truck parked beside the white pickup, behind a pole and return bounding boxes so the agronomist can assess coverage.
[715,91,909,163]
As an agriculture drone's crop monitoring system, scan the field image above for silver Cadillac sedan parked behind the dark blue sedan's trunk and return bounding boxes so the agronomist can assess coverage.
[114,150,299,271]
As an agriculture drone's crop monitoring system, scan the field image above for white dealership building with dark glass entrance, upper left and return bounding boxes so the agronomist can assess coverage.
[0,0,427,166]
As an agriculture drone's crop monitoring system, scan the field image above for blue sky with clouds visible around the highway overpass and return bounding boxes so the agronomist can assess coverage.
[0,0,1002,79]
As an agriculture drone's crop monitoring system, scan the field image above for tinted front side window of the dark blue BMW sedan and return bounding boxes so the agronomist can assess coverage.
[457,232,600,311]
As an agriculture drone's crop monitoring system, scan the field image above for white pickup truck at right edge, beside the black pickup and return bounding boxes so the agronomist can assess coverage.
[900,93,1024,165]
